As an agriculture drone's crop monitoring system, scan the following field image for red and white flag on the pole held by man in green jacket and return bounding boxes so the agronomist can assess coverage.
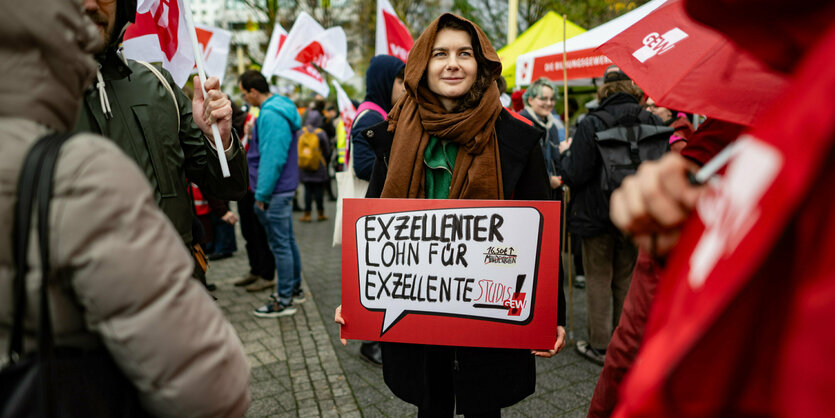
[122,0,194,87]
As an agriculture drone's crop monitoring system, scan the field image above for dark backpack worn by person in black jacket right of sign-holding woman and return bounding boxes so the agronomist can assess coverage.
[590,109,673,198]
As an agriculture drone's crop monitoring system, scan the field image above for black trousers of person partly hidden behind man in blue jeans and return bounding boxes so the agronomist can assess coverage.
[238,191,275,280]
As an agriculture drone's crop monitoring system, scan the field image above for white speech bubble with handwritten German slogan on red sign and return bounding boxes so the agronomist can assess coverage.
[355,207,543,336]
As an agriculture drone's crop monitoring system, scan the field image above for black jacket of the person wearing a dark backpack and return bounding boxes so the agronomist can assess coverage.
[559,93,662,237]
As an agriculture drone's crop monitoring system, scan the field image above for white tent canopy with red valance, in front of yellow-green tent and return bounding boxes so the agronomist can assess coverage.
[516,0,667,86]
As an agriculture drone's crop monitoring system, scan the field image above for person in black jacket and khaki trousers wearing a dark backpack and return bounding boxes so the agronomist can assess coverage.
[559,65,661,366]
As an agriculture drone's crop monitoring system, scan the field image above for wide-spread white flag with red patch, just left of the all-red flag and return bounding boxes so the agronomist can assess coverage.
[273,12,354,80]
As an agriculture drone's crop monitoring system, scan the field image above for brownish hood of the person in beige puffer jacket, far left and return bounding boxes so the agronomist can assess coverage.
[0,0,101,131]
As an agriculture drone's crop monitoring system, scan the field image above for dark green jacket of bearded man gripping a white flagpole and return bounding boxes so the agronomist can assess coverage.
[75,51,247,244]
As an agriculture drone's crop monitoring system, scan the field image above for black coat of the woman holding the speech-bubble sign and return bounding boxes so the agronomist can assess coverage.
[363,110,565,412]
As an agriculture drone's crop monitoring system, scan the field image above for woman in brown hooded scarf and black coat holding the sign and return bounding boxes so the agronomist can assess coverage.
[336,14,565,417]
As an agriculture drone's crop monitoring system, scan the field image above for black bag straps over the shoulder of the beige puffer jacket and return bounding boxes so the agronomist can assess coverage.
[9,133,71,414]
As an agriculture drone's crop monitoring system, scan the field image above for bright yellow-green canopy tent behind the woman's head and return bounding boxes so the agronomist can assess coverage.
[498,11,586,88]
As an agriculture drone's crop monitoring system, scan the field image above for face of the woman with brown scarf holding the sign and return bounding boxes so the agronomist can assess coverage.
[426,28,478,110]
